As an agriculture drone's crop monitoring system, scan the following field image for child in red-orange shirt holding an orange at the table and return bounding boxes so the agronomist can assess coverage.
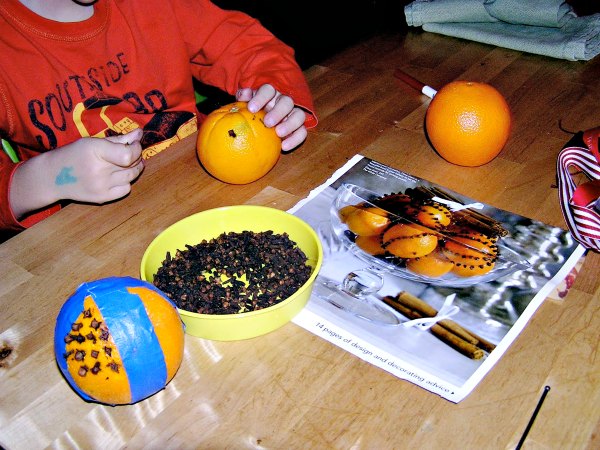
[0,0,316,236]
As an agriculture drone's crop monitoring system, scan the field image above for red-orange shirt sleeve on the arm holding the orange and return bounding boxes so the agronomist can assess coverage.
[178,0,317,128]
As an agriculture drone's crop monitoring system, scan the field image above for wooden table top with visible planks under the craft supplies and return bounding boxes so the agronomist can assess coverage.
[0,31,600,450]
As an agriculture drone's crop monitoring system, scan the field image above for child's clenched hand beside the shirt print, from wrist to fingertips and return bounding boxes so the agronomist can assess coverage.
[54,129,144,203]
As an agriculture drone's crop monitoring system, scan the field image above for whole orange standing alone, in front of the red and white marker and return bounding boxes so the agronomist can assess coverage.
[425,81,511,167]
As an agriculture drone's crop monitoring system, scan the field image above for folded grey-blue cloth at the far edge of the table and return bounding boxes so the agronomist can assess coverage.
[404,0,600,61]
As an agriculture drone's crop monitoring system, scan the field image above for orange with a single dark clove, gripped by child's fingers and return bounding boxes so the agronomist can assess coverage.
[196,102,281,184]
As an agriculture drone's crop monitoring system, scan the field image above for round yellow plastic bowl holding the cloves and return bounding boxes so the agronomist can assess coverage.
[140,205,323,341]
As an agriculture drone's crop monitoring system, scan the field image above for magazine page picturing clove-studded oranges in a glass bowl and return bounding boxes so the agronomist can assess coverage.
[290,155,584,402]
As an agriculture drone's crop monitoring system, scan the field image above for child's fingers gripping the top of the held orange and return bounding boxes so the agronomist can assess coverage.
[236,84,307,152]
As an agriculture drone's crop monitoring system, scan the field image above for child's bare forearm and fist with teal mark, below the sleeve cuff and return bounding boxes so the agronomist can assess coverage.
[9,129,144,219]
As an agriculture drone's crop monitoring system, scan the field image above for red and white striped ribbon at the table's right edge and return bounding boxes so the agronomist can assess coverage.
[557,128,600,251]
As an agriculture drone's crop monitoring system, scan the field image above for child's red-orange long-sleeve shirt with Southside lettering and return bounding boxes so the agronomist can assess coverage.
[0,0,316,230]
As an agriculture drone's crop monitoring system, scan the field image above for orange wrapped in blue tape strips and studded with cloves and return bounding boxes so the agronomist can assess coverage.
[54,277,184,405]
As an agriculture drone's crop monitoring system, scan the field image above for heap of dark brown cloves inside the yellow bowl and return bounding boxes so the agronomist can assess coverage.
[154,231,312,314]
